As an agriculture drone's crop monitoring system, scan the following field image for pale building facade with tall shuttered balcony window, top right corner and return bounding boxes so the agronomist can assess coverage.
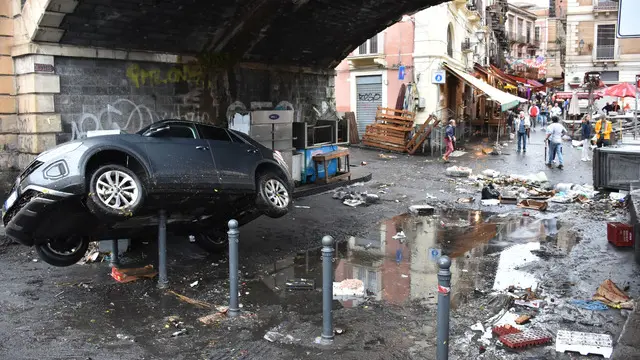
[565,0,640,90]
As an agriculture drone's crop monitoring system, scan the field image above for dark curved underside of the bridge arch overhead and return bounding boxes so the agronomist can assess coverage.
[37,0,443,68]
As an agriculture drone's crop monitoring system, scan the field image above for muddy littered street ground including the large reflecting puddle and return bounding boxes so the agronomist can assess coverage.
[0,133,640,359]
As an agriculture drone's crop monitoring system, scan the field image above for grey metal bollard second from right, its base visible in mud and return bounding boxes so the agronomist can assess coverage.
[321,235,334,344]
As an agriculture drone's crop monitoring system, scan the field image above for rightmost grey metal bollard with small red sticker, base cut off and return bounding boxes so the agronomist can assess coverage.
[436,256,451,360]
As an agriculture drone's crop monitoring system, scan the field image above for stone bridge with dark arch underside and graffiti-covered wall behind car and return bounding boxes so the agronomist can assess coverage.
[0,0,444,169]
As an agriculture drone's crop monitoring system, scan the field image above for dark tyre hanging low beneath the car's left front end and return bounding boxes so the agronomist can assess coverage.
[36,236,89,266]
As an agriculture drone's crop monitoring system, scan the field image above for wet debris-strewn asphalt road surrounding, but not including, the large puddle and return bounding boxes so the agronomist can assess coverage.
[0,132,640,359]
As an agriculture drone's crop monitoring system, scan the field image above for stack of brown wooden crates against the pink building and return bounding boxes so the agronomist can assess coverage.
[362,107,415,152]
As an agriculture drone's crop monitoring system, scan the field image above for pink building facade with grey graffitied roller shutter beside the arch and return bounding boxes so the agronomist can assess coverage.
[335,20,414,135]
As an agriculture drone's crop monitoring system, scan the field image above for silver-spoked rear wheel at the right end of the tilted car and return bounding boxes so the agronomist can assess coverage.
[256,172,292,218]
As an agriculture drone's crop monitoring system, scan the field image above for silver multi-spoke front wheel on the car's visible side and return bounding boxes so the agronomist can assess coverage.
[87,164,144,218]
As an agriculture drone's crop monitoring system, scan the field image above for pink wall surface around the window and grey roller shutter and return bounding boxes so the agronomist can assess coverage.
[335,17,415,111]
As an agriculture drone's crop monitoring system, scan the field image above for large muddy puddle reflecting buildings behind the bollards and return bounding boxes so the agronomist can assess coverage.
[243,210,577,313]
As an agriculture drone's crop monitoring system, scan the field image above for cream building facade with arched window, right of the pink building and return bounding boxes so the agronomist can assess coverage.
[414,1,490,123]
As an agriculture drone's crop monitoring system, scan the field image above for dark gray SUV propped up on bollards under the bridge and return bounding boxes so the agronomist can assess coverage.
[2,120,293,266]
